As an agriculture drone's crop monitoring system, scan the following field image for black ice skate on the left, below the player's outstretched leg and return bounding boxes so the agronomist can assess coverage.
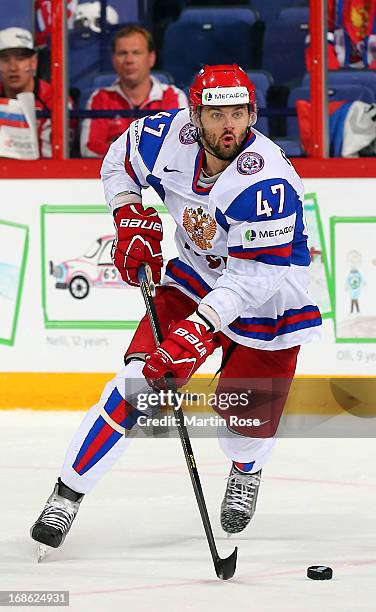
[30,478,83,561]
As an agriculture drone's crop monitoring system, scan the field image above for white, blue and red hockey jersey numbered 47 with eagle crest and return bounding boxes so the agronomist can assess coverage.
[101,109,321,350]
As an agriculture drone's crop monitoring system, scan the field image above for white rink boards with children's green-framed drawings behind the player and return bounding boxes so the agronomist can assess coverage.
[0,178,376,409]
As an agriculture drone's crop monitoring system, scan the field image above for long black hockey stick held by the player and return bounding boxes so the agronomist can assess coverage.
[138,264,238,580]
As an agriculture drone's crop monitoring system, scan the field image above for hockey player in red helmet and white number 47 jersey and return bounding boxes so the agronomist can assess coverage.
[31,65,321,547]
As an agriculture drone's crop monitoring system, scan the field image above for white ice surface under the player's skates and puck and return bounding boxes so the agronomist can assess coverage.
[0,411,376,612]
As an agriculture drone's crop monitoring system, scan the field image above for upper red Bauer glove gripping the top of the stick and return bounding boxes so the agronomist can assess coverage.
[112,204,163,287]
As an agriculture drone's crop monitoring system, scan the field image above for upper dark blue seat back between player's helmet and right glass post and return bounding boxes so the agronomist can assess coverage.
[262,8,309,86]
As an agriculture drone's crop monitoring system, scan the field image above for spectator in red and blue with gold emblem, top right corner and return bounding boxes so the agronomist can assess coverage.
[306,0,376,71]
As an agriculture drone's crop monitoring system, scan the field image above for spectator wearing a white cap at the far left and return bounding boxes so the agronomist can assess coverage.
[0,28,52,157]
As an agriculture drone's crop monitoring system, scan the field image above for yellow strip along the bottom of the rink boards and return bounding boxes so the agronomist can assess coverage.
[0,372,376,416]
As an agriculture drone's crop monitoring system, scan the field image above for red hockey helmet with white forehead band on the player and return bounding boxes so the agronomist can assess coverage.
[189,64,256,112]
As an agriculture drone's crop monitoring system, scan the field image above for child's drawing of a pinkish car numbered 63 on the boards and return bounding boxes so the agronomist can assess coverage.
[50,235,125,300]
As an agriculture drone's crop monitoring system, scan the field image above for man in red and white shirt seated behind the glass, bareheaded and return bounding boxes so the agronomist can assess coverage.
[81,25,188,157]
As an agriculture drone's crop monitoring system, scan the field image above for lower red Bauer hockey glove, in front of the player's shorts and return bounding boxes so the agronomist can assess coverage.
[142,313,217,388]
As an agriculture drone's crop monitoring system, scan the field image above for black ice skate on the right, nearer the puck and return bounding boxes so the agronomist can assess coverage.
[221,465,261,534]
